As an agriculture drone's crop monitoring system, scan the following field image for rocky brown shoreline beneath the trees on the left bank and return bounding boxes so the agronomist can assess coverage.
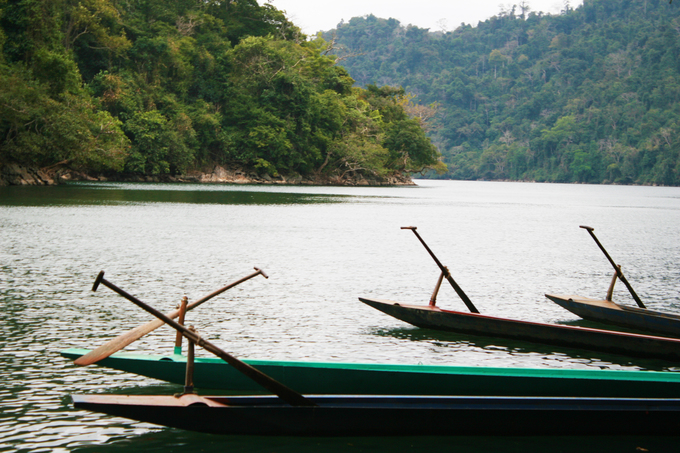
[0,163,416,186]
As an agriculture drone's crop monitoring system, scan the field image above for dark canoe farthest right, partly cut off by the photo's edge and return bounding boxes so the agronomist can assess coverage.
[545,294,680,338]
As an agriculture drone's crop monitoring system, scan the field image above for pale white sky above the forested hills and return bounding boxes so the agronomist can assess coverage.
[258,0,583,35]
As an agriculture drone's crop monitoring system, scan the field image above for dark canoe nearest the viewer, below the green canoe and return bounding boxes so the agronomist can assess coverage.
[72,395,680,436]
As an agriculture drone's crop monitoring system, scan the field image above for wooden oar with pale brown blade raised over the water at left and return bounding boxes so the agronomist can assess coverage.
[74,267,269,366]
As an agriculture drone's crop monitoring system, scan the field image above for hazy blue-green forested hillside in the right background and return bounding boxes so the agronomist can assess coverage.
[324,0,680,185]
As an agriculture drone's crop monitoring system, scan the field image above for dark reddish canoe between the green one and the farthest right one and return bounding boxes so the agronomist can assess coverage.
[359,297,680,360]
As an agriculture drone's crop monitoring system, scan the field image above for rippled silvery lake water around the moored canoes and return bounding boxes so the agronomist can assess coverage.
[0,180,680,452]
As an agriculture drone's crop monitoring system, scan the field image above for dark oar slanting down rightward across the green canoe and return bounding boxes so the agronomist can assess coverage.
[92,271,316,406]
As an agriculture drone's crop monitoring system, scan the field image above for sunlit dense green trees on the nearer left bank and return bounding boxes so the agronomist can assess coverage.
[0,0,439,177]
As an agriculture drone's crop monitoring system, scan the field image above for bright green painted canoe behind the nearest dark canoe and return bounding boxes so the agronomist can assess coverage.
[61,349,680,398]
